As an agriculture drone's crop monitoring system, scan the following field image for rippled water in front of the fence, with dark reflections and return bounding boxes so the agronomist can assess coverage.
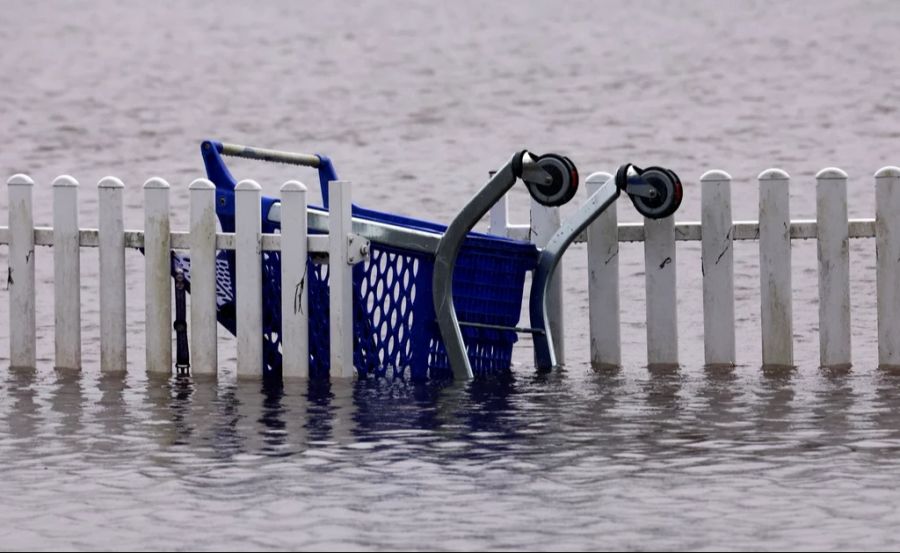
[0,367,900,549]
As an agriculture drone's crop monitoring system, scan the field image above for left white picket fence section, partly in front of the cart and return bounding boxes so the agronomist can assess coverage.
[0,174,368,378]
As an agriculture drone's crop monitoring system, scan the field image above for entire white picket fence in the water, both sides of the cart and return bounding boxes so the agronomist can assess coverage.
[0,167,900,378]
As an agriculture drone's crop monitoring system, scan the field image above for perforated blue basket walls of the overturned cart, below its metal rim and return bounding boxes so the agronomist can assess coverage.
[180,222,532,381]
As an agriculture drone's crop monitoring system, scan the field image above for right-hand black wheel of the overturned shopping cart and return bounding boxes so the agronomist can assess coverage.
[616,164,684,219]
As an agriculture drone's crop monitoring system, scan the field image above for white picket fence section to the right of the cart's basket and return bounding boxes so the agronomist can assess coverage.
[490,167,900,367]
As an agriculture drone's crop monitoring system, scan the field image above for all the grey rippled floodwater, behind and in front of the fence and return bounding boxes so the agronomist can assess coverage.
[0,0,900,550]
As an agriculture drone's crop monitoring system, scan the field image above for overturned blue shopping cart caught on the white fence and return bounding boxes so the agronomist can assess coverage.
[172,141,681,381]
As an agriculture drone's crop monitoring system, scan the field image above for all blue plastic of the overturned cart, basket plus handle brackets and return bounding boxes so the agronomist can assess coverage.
[173,143,538,380]
